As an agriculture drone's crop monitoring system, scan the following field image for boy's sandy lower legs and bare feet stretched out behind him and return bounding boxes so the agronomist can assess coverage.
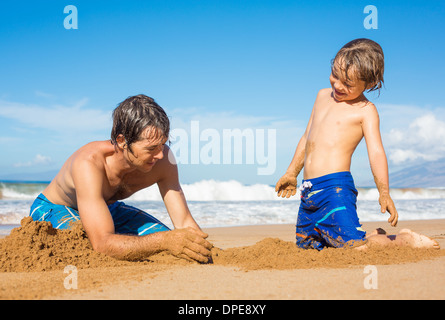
[355,228,440,250]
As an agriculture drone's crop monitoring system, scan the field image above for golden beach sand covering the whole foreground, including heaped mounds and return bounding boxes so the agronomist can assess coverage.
[0,218,445,300]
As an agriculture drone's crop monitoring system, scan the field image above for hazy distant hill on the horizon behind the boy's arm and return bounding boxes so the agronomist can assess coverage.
[389,159,445,188]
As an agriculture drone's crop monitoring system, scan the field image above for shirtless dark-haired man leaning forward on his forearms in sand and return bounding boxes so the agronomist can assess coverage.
[30,95,212,263]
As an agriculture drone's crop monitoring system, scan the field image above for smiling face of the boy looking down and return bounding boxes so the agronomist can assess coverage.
[329,61,366,102]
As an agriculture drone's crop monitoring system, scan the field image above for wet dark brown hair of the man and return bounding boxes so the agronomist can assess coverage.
[111,94,170,151]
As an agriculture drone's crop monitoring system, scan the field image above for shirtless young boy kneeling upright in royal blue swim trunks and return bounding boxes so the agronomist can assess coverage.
[275,39,439,250]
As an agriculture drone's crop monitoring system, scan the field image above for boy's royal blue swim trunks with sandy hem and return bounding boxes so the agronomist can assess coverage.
[296,171,367,250]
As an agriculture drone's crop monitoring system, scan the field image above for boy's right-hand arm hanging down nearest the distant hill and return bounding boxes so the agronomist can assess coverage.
[362,104,399,227]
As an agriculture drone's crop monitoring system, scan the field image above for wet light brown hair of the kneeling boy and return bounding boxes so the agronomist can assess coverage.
[331,38,384,92]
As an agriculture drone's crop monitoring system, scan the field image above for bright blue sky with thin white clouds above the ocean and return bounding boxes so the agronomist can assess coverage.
[0,0,445,185]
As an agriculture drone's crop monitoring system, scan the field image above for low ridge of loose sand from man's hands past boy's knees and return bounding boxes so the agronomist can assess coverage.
[212,238,445,270]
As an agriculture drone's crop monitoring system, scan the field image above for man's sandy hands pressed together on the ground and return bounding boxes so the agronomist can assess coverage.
[164,227,213,263]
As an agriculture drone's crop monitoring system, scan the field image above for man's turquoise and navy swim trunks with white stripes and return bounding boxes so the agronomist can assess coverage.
[29,194,170,236]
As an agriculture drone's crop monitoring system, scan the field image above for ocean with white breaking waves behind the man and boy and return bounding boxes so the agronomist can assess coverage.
[0,180,445,236]
